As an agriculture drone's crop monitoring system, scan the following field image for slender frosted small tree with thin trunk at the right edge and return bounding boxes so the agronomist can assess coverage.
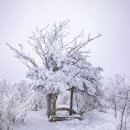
[105,74,130,130]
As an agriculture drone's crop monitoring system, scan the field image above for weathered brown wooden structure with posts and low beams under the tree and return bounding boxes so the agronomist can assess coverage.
[47,87,82,122]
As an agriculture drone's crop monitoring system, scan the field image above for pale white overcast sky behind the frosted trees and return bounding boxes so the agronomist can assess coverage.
[0,0,130,82]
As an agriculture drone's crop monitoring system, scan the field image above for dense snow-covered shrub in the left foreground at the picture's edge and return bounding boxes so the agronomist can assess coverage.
[0,80,38,129]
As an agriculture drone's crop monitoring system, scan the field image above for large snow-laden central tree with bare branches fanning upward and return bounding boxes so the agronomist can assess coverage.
[7,20,102,117]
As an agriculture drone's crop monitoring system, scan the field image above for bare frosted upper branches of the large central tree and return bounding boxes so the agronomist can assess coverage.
[7,20,101,69]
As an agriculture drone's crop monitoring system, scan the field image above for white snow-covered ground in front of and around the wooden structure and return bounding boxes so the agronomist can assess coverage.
[14,111,129,130]
